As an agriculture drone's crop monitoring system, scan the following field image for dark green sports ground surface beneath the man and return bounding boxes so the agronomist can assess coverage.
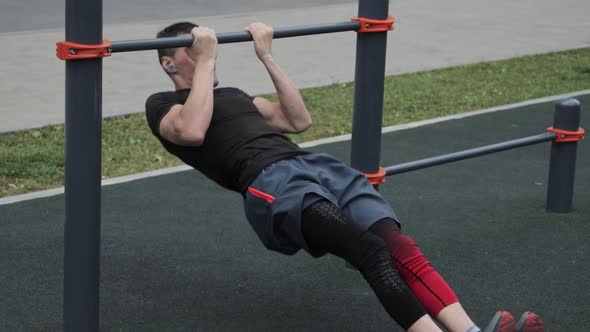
[0,96,590,331]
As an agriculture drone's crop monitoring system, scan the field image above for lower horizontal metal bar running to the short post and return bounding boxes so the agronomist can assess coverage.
[385,133,556,176]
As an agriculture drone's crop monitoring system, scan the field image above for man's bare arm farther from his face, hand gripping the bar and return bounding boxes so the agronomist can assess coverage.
[246,23,312,133]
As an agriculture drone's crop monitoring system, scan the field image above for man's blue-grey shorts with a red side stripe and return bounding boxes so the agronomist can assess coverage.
[244,153,398,255]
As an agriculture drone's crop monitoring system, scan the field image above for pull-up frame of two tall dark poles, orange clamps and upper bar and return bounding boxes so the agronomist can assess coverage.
[58,0,393,332]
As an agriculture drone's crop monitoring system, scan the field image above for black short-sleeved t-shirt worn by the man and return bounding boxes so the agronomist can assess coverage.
[146,88,308,193]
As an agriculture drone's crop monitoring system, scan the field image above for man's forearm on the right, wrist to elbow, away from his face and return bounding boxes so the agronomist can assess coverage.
[261,54,311,130]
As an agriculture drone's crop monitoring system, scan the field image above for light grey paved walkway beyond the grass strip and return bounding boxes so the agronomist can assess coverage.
[0,0,590,132]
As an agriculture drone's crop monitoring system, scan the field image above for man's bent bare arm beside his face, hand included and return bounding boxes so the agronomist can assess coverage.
[160,27,217,146]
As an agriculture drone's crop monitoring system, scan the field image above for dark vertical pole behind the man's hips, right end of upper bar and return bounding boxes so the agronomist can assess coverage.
[351,0,389,173]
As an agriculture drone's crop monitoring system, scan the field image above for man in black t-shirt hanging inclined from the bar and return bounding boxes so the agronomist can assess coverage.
[146,22,542,332]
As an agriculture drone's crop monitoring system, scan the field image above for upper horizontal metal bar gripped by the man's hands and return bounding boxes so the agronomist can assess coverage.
[111,21,360,53]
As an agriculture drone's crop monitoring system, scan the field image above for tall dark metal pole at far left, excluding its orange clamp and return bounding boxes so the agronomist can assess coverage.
[63,0,102,332]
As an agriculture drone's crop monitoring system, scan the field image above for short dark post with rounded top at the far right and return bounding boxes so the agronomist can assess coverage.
[546,98,580,213]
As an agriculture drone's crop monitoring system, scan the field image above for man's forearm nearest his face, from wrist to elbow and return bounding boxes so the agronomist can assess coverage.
[177,59,215,140]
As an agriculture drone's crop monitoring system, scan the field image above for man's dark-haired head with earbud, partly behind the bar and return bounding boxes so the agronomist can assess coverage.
[156,22,218,90]
